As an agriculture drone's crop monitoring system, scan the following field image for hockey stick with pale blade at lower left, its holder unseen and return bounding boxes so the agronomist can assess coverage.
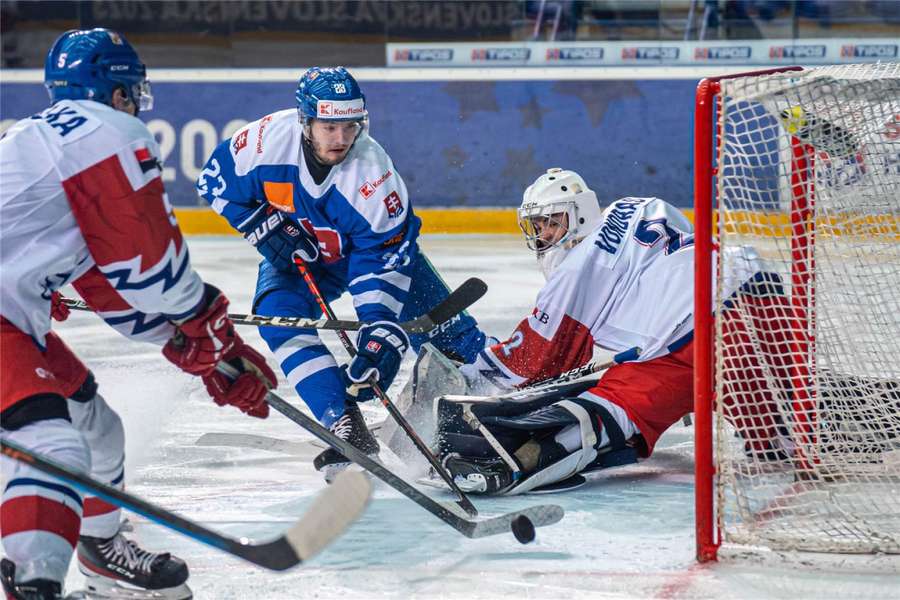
[0,440,372,571]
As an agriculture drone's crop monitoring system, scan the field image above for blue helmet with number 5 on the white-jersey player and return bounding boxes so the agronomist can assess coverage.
[44,27,153,110]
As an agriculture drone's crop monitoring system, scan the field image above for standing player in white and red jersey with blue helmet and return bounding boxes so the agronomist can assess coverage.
[0,29,276,600]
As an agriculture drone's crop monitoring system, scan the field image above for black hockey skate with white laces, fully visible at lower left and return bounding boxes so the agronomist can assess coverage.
[78,521,193,600]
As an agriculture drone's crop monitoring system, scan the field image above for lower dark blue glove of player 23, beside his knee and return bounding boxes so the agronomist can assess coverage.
[341,321,409,402]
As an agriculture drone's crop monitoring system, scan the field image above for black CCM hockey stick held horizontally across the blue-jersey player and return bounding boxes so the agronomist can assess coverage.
[63,277,487,333]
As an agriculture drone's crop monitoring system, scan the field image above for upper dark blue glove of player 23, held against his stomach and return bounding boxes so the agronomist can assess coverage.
[237,204,319,273]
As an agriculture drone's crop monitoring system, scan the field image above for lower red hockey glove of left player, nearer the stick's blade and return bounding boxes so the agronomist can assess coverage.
[203,335,278,419]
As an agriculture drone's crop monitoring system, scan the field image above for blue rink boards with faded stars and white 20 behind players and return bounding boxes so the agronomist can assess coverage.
[0,71,696,207]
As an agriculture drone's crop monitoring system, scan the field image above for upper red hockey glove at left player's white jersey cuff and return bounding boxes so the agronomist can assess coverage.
[163,283,237,375]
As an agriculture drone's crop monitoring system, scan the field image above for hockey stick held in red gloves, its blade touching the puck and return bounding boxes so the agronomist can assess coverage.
[216,362,565,538]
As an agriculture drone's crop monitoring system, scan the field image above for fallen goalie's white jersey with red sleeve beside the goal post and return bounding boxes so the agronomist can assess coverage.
[467,197,759,388]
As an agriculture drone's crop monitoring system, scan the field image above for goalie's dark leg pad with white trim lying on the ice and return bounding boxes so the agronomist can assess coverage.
[435,380,646,495]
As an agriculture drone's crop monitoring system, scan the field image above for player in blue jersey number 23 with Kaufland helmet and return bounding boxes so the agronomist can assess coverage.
[197,67,485,480]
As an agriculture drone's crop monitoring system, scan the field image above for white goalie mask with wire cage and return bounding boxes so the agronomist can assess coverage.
[518,168,602,279]
